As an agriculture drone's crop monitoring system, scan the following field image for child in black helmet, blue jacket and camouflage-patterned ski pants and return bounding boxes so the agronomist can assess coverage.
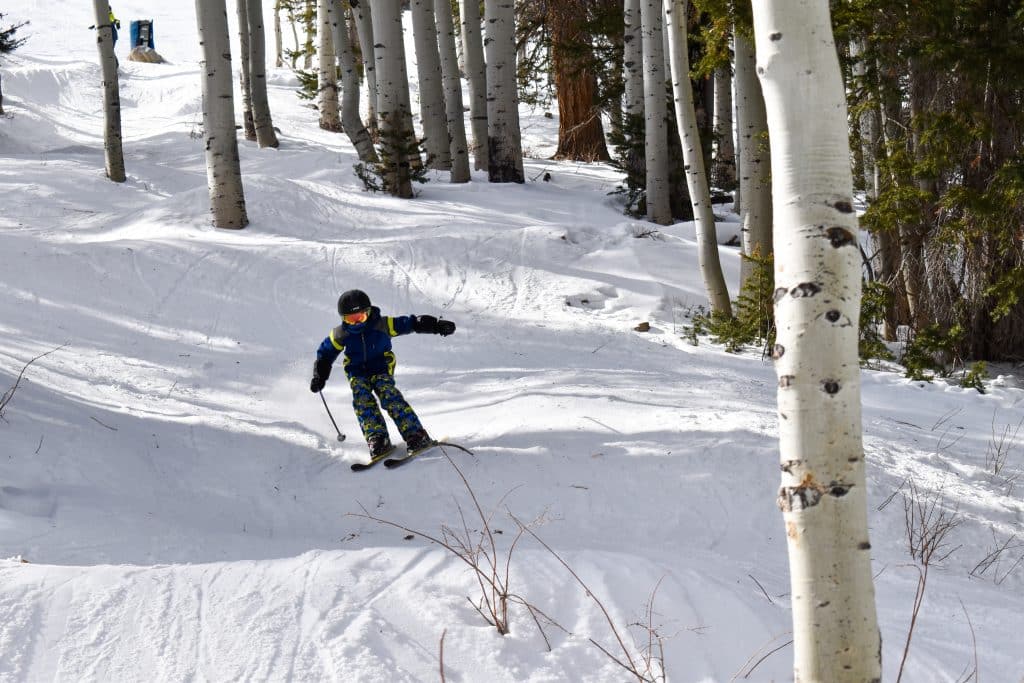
[309,290,455,461]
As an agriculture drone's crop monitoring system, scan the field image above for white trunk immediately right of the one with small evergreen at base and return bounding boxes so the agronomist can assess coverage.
[410,0,452,170]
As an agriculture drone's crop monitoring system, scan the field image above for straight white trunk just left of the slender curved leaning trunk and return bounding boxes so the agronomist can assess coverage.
[640,0,672,225]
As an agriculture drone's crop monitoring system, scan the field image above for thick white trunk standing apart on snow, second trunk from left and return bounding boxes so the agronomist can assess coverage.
[196,0,249,228]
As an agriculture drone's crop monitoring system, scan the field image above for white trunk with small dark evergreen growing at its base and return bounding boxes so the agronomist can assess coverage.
[373,0,420,198]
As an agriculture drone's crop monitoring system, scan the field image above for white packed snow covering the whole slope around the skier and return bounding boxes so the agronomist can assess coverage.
[0,0,1024,683]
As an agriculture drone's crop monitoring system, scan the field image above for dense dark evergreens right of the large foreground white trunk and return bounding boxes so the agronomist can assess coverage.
[836,0,1024,360]
